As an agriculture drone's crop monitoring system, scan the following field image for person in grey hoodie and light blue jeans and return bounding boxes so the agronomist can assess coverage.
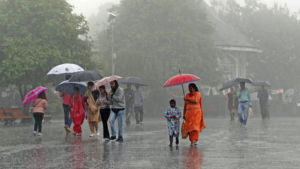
[109,80,126,142]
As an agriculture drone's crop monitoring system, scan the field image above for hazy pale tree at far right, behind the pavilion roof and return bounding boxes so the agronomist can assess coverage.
[213,0,300,88]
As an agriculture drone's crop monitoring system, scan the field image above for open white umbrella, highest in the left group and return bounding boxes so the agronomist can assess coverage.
[47,63,84,75]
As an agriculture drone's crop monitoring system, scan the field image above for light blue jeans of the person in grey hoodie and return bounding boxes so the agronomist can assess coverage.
[110,109,125,137]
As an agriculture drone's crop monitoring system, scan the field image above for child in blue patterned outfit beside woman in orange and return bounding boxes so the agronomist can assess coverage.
[165,99,181,147]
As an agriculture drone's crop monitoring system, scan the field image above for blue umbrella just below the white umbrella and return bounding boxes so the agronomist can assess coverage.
[55,80,87,95]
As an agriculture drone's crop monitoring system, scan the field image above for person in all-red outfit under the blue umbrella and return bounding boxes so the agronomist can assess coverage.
[70,87,86,136]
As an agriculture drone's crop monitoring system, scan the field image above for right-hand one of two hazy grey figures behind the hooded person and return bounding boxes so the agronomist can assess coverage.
[133,85,144,125]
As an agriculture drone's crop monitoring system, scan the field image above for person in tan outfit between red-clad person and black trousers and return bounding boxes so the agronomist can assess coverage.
[84,82,100,137]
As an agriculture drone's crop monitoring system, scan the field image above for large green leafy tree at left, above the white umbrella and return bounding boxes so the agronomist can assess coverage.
[0,0,99,109]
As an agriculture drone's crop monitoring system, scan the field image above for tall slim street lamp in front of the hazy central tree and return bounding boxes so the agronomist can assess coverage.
[107,12,117,75]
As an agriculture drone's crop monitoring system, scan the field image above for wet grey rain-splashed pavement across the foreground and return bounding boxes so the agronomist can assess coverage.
[0,117,300,169]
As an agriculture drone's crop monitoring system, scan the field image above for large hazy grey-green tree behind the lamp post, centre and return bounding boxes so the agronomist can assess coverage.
[98,0,219,88]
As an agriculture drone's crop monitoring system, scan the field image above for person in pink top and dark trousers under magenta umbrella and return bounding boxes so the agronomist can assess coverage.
[32,92,48,136]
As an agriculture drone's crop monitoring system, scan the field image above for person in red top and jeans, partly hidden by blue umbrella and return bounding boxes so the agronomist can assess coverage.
[59,75,73,133]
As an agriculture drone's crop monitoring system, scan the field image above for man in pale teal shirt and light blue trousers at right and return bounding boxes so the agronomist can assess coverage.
[236,82,252,126]
